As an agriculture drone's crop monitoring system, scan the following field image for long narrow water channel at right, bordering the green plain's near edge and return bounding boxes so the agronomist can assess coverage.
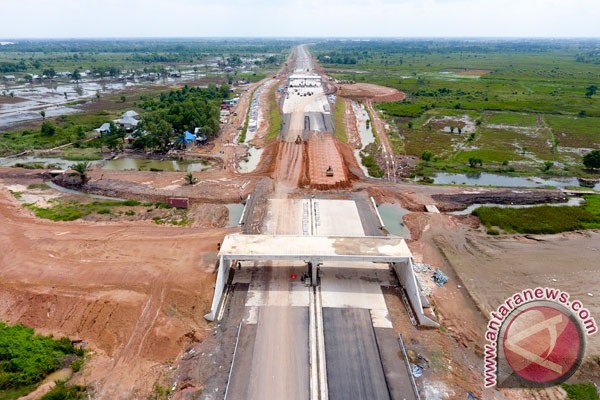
[433,172,600,191]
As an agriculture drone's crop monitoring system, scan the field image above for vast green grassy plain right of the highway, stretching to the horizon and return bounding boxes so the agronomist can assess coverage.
[312,40,600,174]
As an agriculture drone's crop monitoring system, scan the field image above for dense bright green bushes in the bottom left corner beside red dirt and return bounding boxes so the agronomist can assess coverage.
[0,322,83,393]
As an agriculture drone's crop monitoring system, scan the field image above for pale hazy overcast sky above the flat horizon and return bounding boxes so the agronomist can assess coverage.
[0,0,600,39]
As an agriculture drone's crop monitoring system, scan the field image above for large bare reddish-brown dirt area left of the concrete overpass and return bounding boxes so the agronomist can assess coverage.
[0,189,226,399]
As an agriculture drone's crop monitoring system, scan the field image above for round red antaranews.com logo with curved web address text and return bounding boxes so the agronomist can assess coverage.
[484,287,598,388]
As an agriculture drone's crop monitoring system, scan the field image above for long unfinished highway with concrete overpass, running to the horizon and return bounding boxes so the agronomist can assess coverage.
[206,46,436,400]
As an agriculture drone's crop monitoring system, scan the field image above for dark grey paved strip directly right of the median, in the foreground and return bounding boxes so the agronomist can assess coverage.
[323,308,390,400]
